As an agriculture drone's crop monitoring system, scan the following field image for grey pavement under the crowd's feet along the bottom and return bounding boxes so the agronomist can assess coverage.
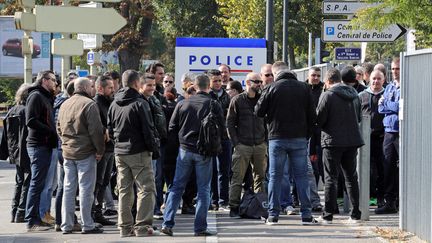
[0,161,417,243]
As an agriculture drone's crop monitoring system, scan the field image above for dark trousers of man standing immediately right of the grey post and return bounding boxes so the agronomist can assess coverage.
[370,133,384,199]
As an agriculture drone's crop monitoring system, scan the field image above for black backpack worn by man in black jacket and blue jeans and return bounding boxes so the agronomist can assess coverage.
[197,100,222,156]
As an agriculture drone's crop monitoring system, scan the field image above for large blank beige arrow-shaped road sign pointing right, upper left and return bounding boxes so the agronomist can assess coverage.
[34,5,126,35]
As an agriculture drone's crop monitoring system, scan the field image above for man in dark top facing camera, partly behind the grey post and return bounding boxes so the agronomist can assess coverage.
[359,70,385,207]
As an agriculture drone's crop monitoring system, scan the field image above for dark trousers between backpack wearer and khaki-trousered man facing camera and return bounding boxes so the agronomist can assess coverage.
[211,139,232,205]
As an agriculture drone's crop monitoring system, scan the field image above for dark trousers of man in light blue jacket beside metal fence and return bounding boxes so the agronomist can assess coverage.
[383,132,399,203]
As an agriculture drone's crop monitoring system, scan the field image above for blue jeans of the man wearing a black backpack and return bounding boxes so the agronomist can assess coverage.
[162,149,213,232]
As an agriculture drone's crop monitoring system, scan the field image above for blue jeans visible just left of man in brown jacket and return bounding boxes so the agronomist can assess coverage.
[39,148,58,217]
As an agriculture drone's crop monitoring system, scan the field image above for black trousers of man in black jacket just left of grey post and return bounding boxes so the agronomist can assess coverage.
[323,147,361,220]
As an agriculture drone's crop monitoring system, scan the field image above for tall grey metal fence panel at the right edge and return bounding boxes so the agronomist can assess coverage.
[399,49,432,242]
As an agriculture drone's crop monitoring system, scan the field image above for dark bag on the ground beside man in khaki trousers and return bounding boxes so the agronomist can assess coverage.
[239,190,268,219]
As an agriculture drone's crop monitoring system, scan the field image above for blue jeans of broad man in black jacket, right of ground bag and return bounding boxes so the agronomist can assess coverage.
[268,138,312,218]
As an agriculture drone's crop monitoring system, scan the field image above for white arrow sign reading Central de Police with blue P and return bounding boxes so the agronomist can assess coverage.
[321,20,406,42]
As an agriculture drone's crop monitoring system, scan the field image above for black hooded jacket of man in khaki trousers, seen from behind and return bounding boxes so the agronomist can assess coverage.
[107,87,159,154]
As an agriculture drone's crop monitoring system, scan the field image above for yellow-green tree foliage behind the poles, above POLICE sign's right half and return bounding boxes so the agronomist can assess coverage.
[217,0,322,68]
